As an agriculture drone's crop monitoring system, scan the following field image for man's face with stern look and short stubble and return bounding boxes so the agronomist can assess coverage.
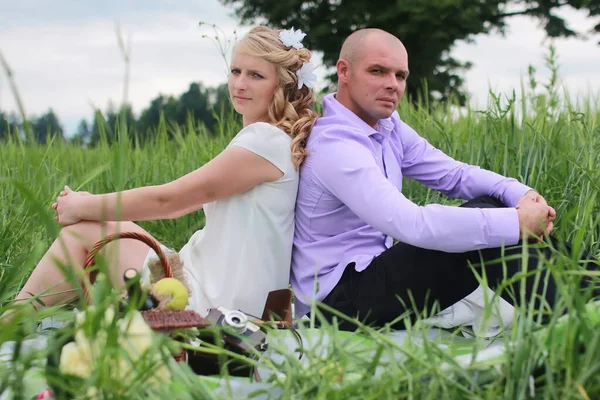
[340,37,408,127]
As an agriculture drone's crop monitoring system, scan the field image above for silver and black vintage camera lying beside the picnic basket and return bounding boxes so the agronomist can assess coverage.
[188,307,267,376]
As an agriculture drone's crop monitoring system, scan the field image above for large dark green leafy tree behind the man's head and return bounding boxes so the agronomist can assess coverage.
[220,0,600,102]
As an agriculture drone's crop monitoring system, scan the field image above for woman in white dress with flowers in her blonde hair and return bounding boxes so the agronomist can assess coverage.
[17,27,317,315]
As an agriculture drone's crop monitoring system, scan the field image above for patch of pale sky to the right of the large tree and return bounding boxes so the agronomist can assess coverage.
[453,9,600,106]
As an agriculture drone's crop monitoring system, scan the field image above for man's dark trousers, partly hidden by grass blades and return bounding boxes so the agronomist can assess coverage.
[322,196,598,330]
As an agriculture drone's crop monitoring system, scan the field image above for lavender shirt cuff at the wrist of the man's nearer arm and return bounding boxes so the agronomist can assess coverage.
[481,208,521,247]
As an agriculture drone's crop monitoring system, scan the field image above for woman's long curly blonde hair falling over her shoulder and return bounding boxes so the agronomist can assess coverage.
[235,26,319,168]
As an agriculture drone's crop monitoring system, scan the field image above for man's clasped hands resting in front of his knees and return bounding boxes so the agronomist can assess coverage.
[515,190,556,239]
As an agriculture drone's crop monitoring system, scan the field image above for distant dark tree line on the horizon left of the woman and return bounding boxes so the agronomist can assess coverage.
[0,82,231,146]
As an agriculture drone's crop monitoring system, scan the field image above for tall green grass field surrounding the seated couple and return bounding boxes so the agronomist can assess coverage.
[0,72,600,399]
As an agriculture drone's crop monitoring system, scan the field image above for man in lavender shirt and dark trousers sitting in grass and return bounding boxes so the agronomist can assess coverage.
[291,29,556,328]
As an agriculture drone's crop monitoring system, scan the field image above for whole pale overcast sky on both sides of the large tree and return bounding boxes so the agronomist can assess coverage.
[0,0,600,134]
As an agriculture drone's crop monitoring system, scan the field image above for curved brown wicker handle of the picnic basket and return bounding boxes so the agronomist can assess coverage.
[82,232,173,304]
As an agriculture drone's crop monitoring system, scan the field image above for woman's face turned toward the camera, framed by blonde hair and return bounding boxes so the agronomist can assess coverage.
[228,50,277,126]
